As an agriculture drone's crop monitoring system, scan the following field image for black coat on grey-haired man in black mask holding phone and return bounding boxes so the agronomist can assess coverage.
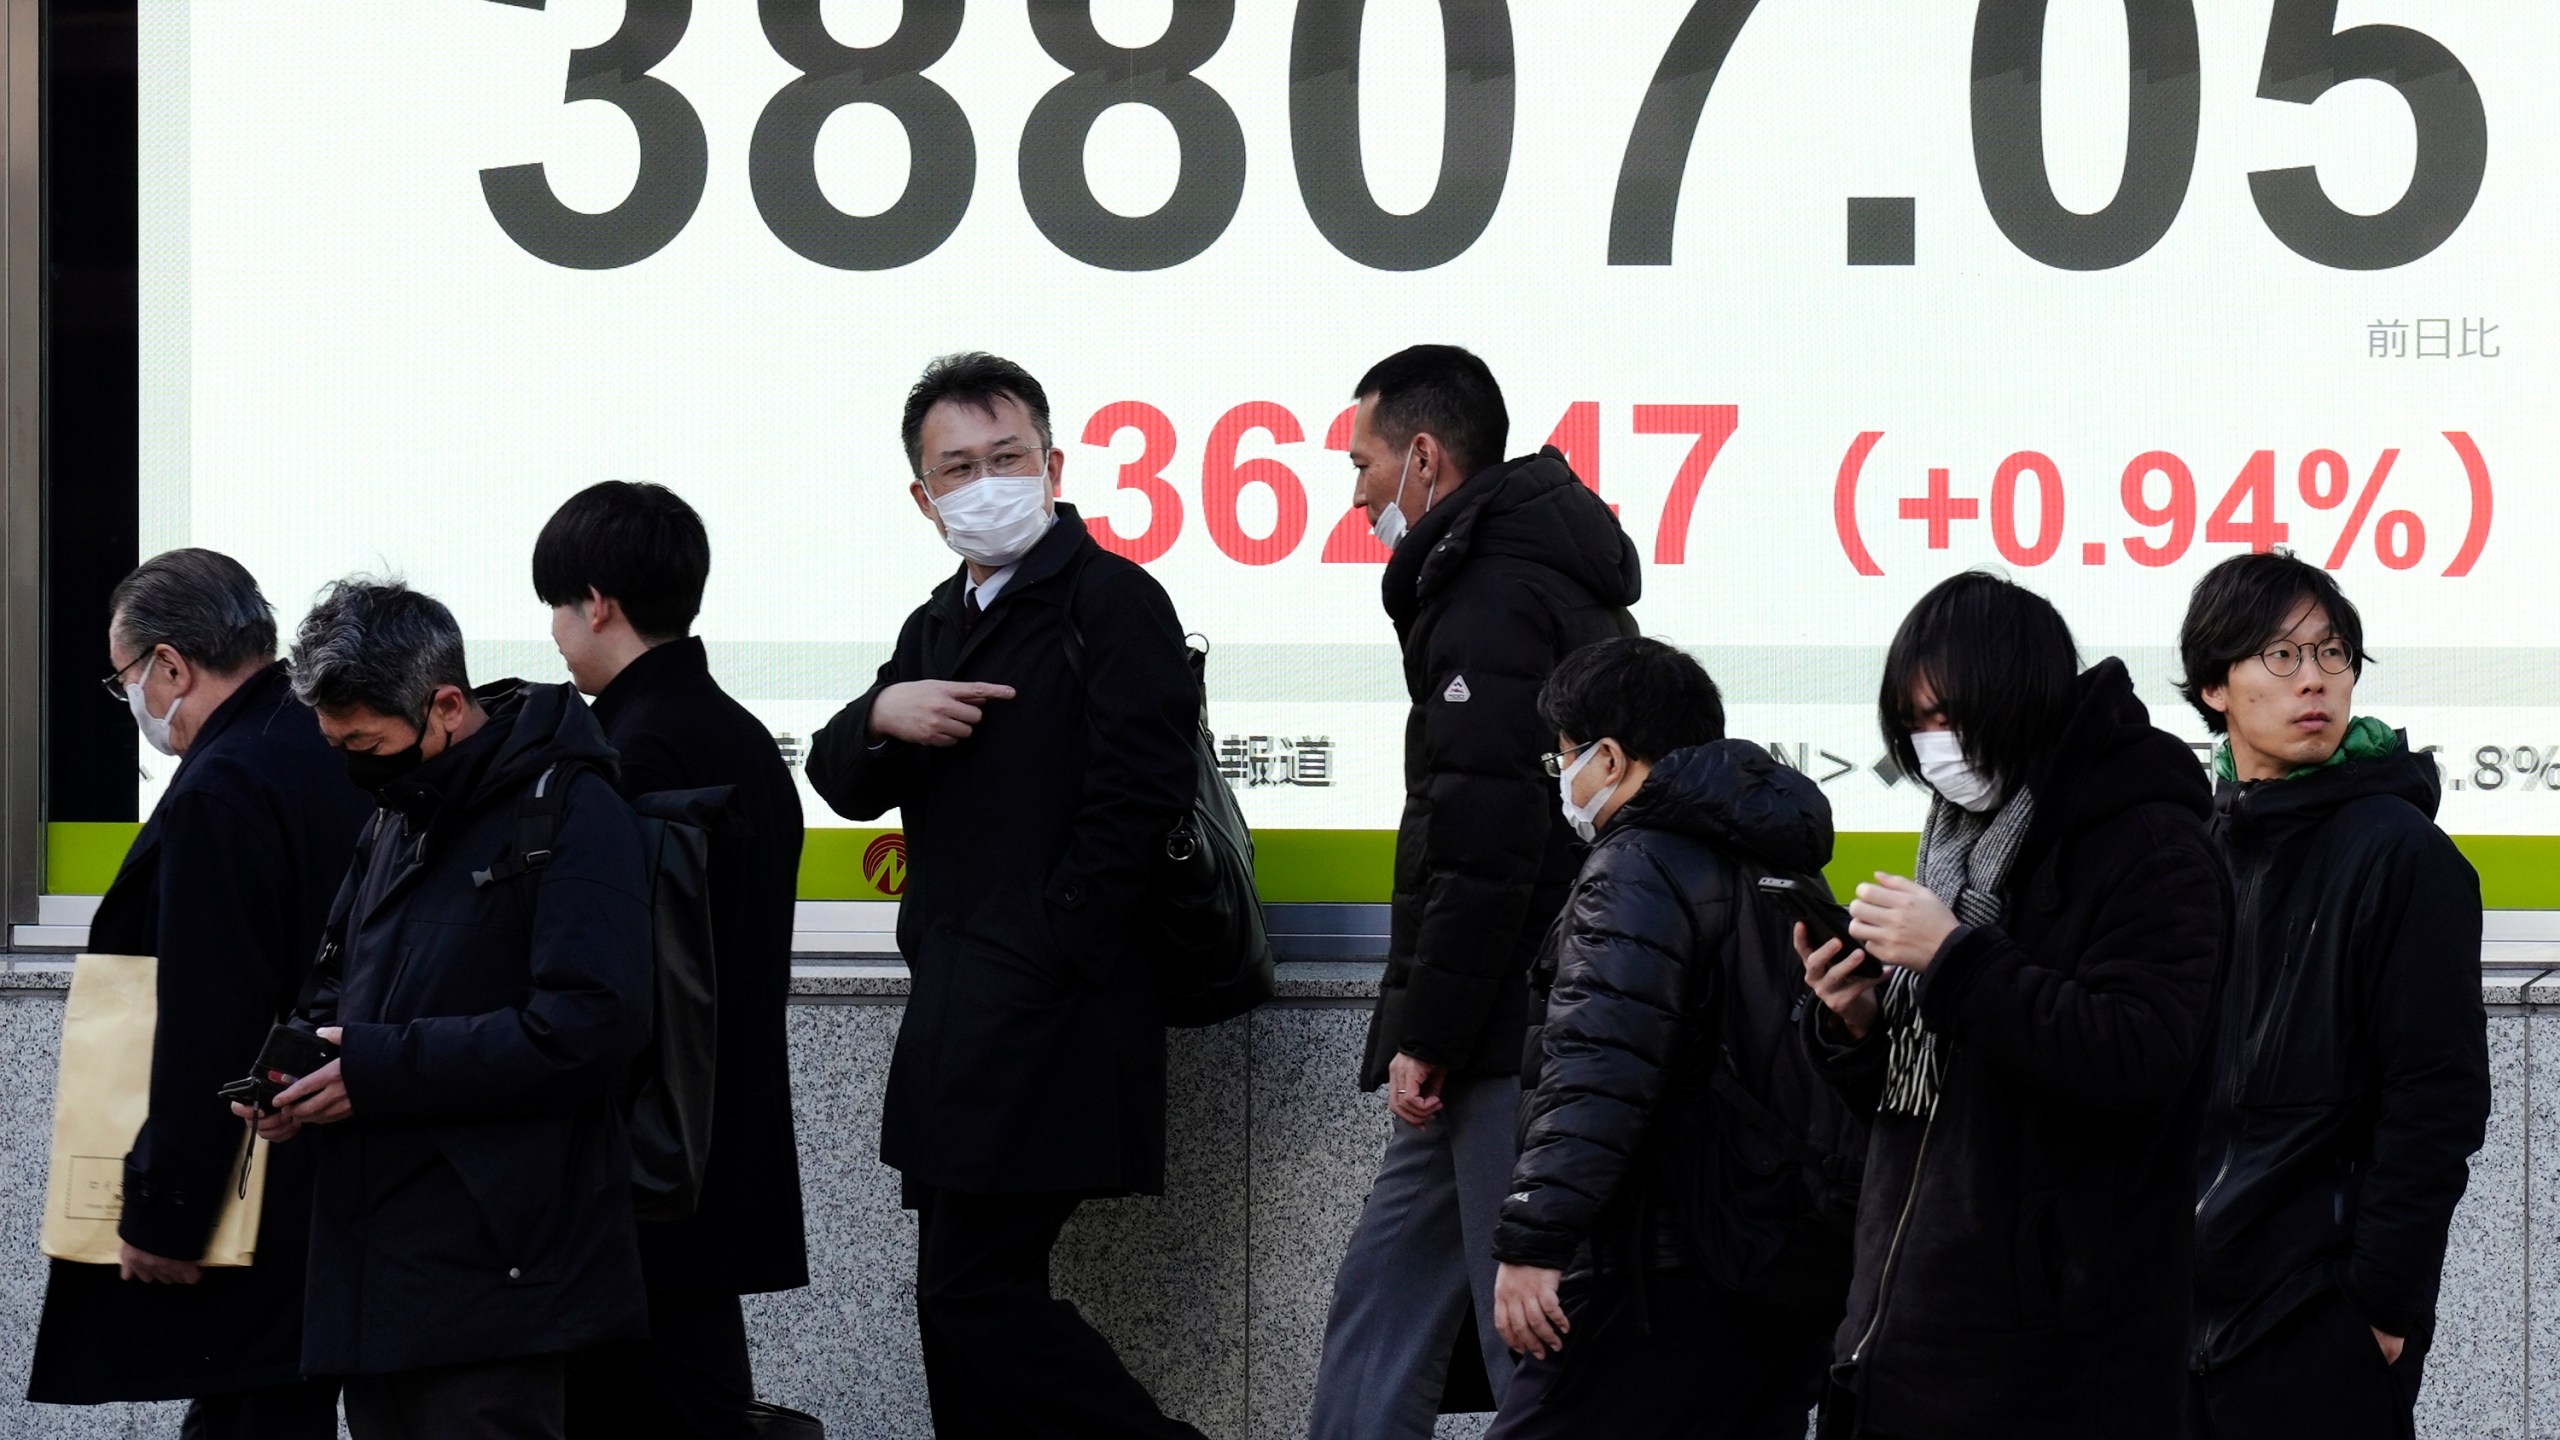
[294,682,650,1376]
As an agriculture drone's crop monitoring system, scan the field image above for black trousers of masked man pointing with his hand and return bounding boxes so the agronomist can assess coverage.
[909,1189,1201,1440]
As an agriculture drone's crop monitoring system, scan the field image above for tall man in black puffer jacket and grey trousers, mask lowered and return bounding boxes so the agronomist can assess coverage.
[1308,346,1638,1440]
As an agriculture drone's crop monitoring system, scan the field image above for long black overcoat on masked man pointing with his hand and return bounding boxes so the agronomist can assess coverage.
[809,505,1201,1197]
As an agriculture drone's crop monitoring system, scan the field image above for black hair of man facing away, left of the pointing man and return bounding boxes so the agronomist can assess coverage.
[532,479,712,641]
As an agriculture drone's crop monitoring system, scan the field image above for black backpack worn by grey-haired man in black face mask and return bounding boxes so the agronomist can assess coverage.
[471,761,740,1220]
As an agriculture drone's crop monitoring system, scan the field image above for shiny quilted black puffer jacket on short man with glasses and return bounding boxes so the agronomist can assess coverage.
[1492,740,1830,1271]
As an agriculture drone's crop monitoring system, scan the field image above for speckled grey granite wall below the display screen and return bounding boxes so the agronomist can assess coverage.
[0,966,2560,1440]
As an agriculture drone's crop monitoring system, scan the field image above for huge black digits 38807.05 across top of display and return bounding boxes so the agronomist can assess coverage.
[481,0,2488,272]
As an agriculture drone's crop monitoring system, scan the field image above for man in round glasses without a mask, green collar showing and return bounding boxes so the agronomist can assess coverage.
[2179,551,2488,1440]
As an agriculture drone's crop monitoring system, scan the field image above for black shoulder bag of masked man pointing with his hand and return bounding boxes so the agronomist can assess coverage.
[1062,569,1277,1030]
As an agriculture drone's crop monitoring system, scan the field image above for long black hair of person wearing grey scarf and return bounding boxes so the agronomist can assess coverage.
[1876,571,2079,794]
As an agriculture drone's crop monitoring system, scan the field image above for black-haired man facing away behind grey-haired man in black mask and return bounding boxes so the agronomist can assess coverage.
[532,479,809,1440]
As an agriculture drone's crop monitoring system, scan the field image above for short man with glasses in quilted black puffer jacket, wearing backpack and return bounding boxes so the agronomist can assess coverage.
[1487,638,1848,1440]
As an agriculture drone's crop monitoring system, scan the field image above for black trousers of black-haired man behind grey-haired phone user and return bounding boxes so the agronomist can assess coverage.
[568,1289,755,1440]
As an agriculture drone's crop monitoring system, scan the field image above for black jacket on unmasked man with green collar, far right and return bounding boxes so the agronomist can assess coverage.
[2191,746,2488,1368]
